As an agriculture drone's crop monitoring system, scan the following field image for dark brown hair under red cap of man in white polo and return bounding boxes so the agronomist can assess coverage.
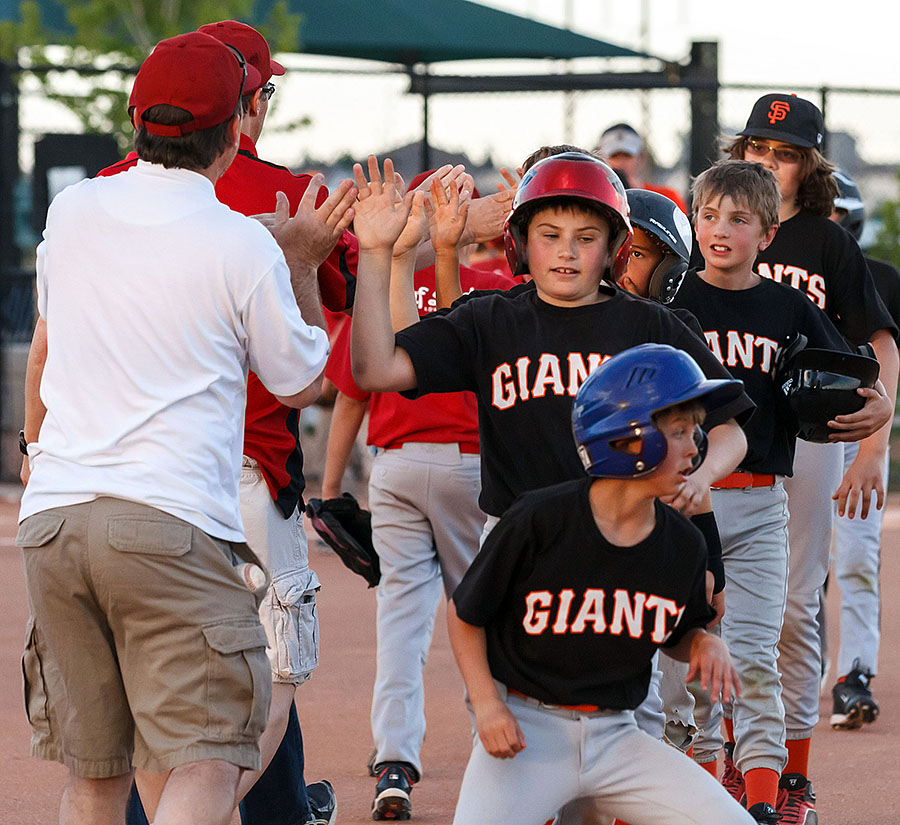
[134,104,241,171]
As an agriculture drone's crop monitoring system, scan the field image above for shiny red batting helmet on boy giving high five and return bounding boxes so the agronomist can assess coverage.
[503,152,633,279]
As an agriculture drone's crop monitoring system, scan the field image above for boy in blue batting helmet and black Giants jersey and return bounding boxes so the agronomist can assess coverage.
[449,344,753,825]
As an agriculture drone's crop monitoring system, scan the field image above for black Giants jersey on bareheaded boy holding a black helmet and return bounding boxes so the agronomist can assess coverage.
[673,271,847,476]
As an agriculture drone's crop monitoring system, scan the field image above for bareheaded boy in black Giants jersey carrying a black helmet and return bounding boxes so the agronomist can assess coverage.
[673,160,875,823]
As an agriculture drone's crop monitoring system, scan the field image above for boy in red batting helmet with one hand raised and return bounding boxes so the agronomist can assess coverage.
[351,153,752,520]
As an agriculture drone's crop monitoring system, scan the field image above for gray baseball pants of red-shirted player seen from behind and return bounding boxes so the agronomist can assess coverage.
[369,443,484,775]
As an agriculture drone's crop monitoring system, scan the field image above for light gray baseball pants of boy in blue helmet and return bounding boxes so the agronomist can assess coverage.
[453,686,754,825]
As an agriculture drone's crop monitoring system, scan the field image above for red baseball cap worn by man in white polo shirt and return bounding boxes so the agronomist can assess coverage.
[128,32,260,137]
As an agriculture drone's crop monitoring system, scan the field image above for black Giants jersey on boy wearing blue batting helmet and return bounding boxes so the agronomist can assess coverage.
[453,478,713,710]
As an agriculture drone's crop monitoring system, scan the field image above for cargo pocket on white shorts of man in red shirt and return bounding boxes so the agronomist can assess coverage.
[272,570,319,684]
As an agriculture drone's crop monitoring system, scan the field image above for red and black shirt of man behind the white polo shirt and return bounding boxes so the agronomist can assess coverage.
[98,140,359,518]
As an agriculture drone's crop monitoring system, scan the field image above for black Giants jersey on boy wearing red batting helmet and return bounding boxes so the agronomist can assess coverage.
[397,289,753,516]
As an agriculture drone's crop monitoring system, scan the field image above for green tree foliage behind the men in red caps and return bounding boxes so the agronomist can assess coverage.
[0,0,300,150]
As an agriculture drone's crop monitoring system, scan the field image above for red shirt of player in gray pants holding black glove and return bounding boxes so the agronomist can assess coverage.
[325,266,515,453]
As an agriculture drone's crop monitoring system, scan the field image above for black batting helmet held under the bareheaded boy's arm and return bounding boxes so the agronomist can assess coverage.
[774,344,878,444]
